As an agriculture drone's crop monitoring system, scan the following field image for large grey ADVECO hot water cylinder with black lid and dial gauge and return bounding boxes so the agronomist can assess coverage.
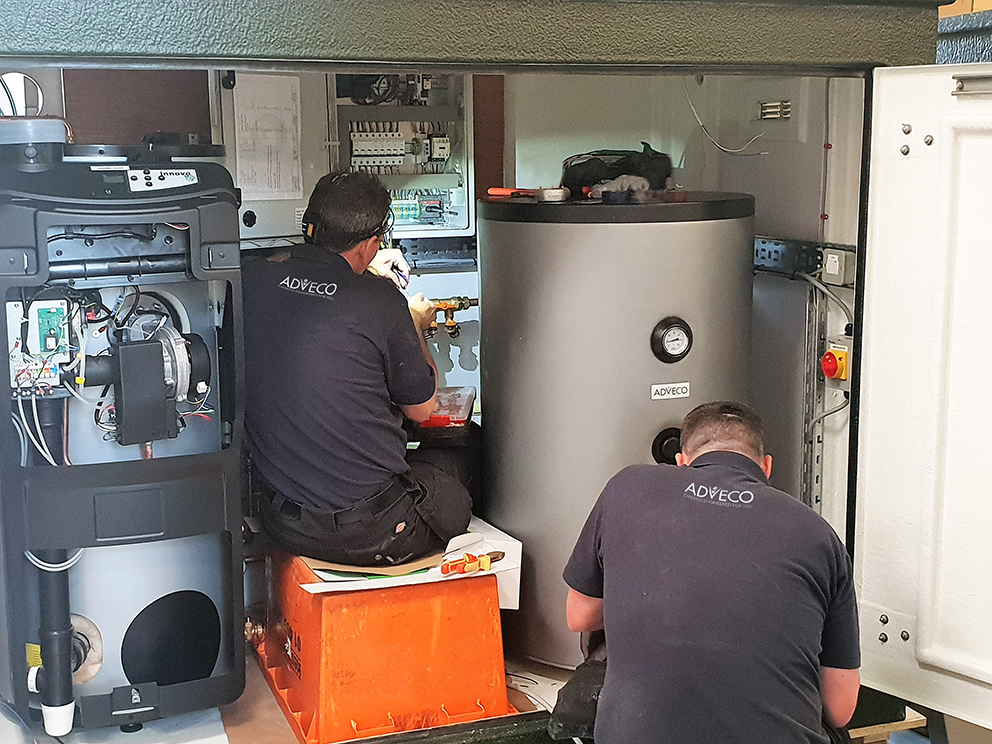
[479,193,754,666]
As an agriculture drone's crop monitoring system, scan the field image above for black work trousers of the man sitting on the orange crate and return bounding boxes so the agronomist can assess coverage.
[251,442,472,567]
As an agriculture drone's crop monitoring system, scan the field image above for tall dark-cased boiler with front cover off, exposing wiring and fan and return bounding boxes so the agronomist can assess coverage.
[0,143,244,736]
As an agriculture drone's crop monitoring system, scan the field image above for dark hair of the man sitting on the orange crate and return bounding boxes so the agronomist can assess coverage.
[303,172,393,253]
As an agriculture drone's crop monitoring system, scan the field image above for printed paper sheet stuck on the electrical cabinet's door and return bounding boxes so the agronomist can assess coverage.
[234,74,303,200]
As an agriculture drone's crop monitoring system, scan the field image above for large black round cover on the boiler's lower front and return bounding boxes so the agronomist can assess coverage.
[121,591,220,685]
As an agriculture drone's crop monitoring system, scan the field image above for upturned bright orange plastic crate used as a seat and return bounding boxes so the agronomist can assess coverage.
[256,555,512,744]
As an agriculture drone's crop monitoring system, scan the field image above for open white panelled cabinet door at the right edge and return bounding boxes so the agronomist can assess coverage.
[856,65,992,728]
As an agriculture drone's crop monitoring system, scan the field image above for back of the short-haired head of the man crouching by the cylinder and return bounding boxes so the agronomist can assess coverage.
[681,400,765,460]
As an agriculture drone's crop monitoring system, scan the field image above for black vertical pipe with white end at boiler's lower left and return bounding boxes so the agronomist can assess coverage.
[35,550,75,736]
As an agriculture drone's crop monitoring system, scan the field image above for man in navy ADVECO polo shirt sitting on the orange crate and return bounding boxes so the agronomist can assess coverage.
[242,173,471,566]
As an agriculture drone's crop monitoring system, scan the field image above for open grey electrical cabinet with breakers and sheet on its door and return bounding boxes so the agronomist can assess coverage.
[216,69,475,243]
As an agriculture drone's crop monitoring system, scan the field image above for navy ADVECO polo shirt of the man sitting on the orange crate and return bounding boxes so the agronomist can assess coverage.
[242,245,435,510]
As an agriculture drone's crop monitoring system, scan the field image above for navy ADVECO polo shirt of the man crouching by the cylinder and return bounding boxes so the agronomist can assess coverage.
[564,452,861,744]
